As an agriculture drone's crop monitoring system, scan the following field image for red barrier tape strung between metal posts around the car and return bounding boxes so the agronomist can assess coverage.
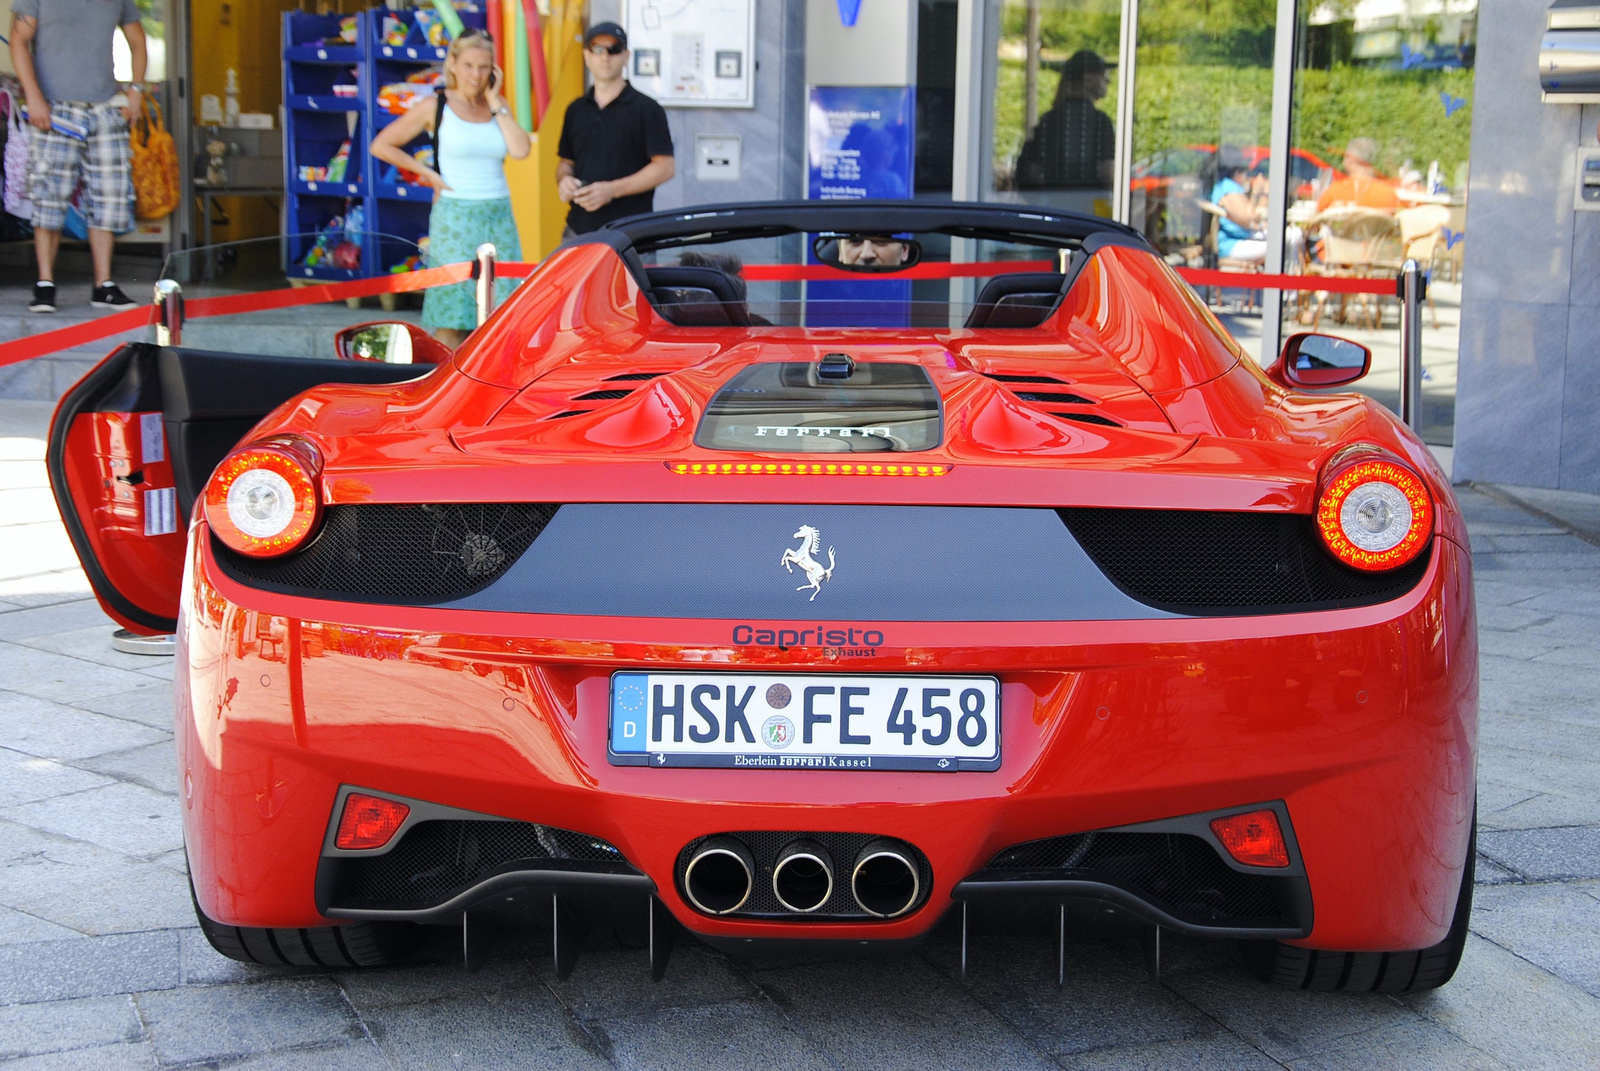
[0,252,1395,367]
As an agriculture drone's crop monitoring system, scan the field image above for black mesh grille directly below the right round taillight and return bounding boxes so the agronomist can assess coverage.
[1056,507,1429,616]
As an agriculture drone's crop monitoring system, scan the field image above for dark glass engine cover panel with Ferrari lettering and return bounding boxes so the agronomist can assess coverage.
[694,362,944,453]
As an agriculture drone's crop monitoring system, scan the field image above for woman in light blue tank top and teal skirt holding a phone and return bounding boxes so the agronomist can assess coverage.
[371,30,533,346]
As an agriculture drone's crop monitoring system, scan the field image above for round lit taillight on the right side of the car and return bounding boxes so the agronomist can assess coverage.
[1317,450,1434,573]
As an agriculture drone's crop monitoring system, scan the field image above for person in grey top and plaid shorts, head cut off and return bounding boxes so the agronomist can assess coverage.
[11,0,146,312]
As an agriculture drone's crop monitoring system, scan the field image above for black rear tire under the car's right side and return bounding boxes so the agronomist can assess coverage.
[1240,807,1478,993]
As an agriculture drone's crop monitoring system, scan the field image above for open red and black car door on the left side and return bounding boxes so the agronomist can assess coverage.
[46,343,432,636]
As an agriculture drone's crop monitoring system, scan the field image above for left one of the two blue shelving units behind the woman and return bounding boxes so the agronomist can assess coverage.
[283,11,376,282]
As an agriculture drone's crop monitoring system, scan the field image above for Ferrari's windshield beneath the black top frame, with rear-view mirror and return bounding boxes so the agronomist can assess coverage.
[642,232,1082,328]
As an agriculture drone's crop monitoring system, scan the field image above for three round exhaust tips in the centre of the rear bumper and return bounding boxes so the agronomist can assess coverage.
[683,836,922,919]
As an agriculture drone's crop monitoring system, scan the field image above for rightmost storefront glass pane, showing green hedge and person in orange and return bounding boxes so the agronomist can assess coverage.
[1283,0,1477,445]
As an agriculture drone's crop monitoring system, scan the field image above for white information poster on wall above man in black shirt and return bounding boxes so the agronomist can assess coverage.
[624,0,755,107]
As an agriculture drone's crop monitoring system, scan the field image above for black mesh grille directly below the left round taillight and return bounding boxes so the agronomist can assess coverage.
[211,503,558,604]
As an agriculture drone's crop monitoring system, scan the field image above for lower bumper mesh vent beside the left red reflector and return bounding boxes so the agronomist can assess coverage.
[325,818,634,909]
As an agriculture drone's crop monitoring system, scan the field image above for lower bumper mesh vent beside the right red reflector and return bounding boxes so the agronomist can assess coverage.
[978,832,1294,927]
